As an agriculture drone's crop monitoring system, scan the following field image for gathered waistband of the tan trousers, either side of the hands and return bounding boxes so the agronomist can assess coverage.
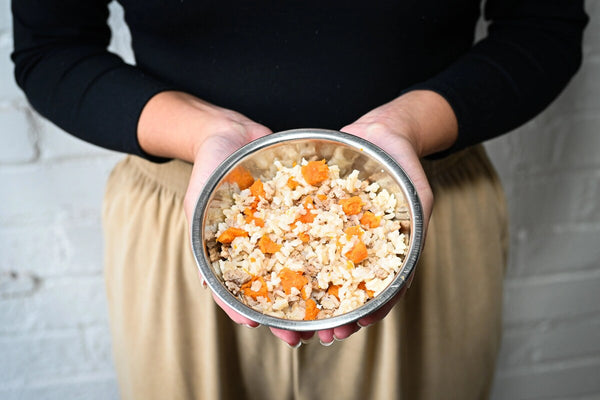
[126,145,487,197]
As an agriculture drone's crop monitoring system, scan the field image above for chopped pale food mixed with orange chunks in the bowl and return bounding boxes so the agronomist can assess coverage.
[206,159,410,320]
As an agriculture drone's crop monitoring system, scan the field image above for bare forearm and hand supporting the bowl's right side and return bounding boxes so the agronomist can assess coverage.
[274,91,458,344]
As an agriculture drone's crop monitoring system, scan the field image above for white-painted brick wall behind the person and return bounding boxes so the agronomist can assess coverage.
[0,0,600,400]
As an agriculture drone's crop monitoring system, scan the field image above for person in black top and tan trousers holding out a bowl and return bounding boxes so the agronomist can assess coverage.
[12,0,587,400]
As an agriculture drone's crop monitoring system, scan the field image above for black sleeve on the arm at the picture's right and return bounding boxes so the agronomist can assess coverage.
[413,0,587,153]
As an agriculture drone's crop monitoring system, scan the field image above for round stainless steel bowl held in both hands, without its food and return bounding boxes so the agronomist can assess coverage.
[191,129,423,331]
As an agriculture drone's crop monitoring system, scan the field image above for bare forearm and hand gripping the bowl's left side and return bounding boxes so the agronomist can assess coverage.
[138,92,271,327]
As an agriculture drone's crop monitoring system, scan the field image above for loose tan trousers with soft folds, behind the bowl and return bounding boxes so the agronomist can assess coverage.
[104,146,507,400]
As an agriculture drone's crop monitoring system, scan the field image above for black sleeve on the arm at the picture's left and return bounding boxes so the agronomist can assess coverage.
[12,0,170,158]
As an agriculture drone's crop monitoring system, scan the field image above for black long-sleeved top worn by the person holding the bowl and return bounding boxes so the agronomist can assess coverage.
[12,0,587,156]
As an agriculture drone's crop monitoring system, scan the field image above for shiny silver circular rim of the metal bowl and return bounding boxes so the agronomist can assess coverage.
[190,128,423,331]
